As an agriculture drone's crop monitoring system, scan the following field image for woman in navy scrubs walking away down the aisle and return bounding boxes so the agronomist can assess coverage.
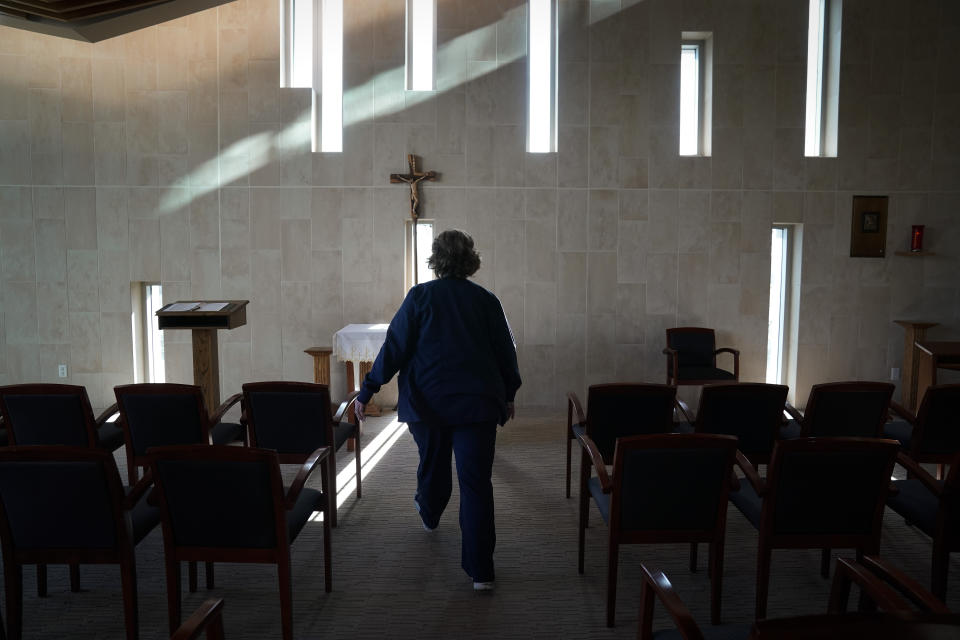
[356,230,520,591]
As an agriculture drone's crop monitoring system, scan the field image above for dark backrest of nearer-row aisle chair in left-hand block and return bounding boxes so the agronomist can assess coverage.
[150,446,288,549]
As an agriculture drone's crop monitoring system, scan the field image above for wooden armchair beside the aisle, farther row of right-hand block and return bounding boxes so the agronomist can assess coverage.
[567,383,677,498]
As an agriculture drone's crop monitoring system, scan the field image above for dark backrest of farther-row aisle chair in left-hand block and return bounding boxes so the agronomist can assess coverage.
[243,382,337,462]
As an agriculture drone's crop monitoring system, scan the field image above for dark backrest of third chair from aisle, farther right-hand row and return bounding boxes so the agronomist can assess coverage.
[801,382,894,438]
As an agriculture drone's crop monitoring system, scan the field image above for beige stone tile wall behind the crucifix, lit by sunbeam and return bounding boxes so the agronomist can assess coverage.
[0,0,960,407]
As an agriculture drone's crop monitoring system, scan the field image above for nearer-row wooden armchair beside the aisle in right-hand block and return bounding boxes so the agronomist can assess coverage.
[578,433,737,627]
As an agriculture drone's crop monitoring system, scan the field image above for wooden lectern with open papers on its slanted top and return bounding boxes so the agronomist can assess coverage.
[157,300,250,411]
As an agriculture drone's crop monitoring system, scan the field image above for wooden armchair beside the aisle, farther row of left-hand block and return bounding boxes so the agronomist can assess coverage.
[243,382,363,527]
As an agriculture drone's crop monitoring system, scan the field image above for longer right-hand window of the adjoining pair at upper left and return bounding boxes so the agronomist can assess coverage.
[313,0,343,153]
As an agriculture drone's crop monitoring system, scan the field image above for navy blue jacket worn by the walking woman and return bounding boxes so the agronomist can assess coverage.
[358,278,520,424]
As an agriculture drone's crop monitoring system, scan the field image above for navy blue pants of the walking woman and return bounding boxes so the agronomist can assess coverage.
[409,422,497,582]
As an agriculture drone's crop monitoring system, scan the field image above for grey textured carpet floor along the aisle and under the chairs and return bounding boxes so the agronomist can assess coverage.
[13,414,960,640]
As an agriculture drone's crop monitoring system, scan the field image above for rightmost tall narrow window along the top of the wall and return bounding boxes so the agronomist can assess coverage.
[804,0,843,156]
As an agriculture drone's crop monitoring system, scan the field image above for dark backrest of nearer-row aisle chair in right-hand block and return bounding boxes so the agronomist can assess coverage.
[610,434,737,543]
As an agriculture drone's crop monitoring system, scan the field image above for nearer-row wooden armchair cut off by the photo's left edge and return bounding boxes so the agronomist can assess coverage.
[0,445,159,640]
